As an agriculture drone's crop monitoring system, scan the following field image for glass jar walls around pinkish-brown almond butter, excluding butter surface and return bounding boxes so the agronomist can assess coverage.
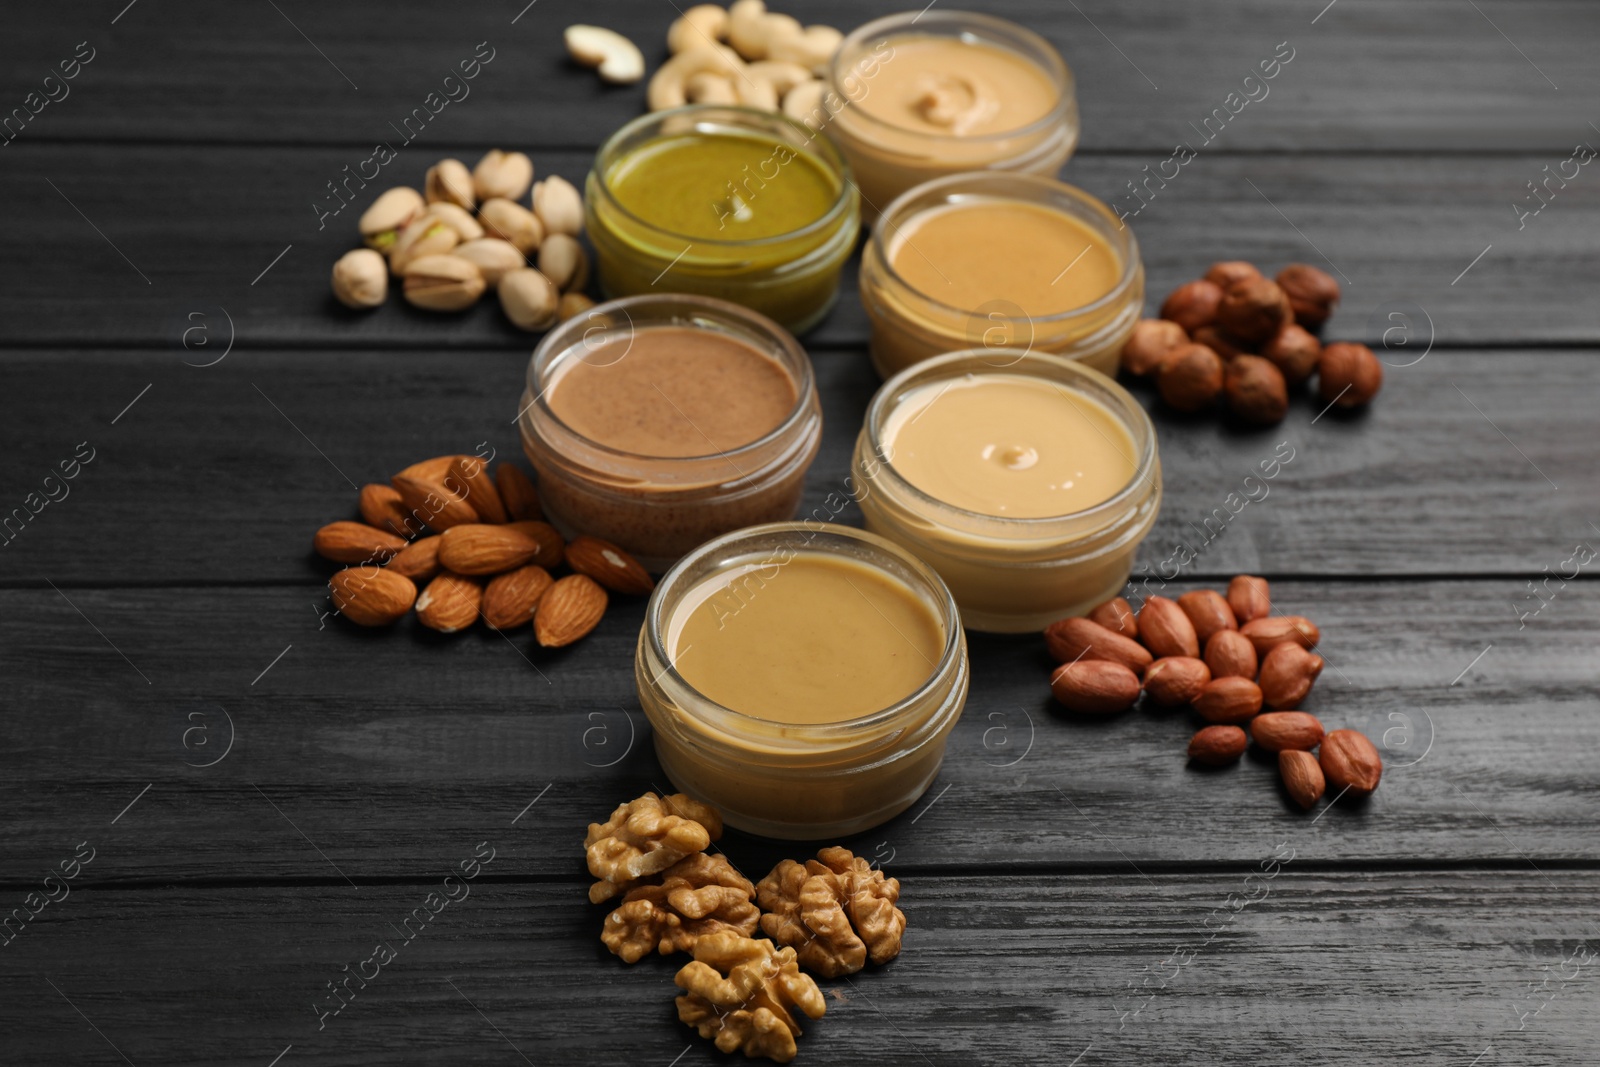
[517,293,822,573]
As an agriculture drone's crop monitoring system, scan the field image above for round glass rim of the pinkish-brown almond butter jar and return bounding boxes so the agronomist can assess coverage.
[517,293,816,474]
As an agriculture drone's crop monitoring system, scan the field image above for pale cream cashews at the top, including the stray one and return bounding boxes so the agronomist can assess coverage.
[566,0,845,122]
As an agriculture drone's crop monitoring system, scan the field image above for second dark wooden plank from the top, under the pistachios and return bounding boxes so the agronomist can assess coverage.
[0,141,1600,348]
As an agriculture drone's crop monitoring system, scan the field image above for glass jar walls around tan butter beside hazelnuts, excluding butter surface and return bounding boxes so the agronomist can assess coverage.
[861,171,1144,385]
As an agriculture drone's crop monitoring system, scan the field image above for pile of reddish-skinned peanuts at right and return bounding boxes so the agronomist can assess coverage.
[1045,574,1382,808]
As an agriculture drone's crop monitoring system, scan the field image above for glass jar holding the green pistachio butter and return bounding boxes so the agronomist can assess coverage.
[584,104,861,333]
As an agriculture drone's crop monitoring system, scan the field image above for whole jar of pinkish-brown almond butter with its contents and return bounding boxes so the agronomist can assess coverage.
[517,293,822,571]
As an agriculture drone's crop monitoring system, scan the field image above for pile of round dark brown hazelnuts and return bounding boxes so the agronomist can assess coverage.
[1122,259,1384,426]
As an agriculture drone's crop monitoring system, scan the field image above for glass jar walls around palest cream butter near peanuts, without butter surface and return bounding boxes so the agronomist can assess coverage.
[851,349,1162,633]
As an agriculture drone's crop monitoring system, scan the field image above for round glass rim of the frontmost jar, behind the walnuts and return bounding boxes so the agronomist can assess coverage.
[643,520,965,741]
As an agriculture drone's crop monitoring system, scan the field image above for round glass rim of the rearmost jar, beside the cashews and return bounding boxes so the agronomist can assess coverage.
[827,8,1077,144]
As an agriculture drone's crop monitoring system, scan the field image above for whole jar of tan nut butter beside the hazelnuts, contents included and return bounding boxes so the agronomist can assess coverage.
[861,171,1144,385]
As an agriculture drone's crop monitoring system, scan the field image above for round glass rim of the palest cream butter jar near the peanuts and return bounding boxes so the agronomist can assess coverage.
[864,349,1160,539]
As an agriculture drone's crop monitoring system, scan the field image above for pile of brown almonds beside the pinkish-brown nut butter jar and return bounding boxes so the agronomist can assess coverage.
[312,456,654,648]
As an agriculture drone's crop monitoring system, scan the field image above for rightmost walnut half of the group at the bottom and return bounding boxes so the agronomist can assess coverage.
[757,846,906,977]
